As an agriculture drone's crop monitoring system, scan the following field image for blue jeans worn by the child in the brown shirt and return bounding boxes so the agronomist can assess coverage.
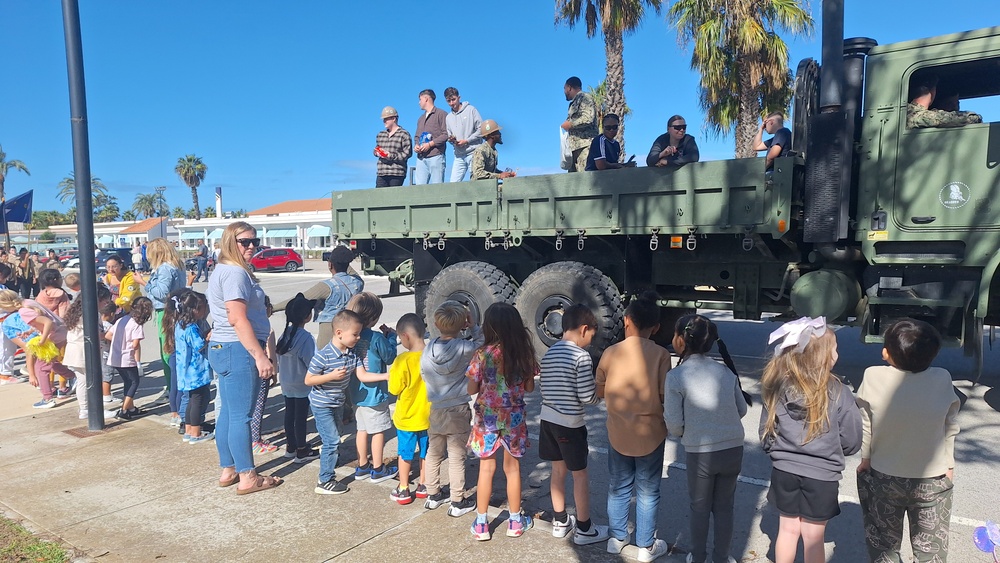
[608,442,665,547]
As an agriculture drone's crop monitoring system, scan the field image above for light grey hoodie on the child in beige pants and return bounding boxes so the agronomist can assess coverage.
[420,326,485,409]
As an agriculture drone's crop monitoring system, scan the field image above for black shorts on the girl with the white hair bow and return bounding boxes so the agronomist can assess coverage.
[767,469,840,522]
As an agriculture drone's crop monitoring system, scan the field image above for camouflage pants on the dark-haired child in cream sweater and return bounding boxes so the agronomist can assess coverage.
[858,469,954,563]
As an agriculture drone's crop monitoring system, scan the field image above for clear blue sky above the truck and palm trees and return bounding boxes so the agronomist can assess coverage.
[0,0,1000,216]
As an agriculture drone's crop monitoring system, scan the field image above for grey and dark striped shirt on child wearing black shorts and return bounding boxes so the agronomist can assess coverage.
[539,340,597,428]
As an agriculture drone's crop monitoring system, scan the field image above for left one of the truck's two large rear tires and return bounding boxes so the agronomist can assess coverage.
[424,262,517,338]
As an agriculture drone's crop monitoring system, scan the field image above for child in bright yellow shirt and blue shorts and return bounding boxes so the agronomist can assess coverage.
[389,313,431,504]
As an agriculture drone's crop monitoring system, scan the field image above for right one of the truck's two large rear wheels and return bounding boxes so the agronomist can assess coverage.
[516,262,625,358]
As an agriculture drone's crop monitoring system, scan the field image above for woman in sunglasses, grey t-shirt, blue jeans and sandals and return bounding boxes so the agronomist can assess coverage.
[206,221,282,495]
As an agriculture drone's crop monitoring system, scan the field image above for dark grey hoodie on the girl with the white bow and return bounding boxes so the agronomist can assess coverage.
[758,379,861,481]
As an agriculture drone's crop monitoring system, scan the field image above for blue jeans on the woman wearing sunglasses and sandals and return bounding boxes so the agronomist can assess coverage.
[208,342,261,473]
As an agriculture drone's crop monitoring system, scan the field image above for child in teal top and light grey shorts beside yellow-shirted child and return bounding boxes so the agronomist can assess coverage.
[346,291,398,483]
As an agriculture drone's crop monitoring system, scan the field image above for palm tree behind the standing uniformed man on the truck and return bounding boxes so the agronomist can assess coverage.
[556,0,663,154]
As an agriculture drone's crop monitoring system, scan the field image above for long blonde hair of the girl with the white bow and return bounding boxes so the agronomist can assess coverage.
[760,328,841,444]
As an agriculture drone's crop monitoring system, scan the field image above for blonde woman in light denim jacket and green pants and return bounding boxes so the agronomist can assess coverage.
[136,238,184,425]
